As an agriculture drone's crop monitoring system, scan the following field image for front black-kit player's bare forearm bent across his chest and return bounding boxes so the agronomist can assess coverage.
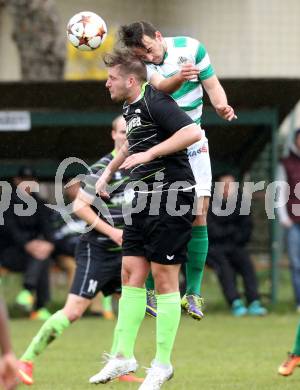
[121,124,201,169]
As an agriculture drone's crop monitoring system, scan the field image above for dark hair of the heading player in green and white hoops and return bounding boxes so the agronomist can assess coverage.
[119,21,157,49]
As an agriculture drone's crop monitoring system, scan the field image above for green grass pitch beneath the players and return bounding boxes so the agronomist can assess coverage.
[3,270,300,390]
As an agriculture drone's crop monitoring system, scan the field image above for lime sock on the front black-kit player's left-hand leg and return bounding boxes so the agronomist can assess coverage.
[111,286,146,358]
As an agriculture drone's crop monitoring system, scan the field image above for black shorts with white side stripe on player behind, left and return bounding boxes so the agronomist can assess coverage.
[70,241,122,299]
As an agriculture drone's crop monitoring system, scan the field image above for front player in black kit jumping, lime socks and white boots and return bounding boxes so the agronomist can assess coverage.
[90,51,201,390]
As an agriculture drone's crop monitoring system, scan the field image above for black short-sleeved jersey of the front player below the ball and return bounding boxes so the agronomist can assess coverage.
[123,83,195,189]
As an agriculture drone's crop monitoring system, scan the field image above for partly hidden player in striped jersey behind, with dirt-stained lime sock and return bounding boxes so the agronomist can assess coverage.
[19,116,128,385]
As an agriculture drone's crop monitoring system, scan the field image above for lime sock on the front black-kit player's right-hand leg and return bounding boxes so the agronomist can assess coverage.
[155,292,181,364]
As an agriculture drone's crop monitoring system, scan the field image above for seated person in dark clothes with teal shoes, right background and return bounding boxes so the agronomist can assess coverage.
[207,174,267,317]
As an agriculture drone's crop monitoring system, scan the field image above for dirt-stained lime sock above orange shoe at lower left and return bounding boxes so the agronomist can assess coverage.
[21,310,70,361]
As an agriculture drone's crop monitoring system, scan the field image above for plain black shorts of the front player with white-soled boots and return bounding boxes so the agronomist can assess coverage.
[123,191,195,265]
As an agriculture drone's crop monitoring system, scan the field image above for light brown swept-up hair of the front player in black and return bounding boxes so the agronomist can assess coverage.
[103,50,147,82]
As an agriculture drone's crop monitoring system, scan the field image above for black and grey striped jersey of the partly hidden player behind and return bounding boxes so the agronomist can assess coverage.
[81,151,129,251]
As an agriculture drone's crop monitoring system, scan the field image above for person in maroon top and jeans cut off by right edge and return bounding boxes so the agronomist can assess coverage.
[277,129,300,312]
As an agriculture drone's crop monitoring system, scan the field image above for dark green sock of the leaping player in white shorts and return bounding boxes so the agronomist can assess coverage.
[186,226,208,295]
